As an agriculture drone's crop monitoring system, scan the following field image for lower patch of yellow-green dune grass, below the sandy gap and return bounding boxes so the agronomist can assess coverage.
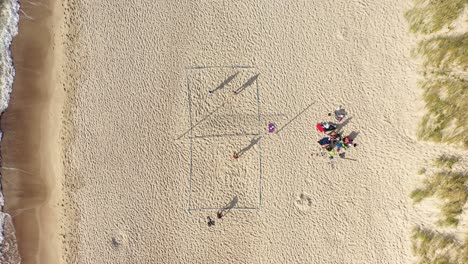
[411,155,468,264]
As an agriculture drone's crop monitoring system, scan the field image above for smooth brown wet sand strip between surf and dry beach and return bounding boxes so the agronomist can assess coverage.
[1,0,64,264]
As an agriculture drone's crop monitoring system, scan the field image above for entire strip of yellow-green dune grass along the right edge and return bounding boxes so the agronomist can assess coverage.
[405,0,468,264]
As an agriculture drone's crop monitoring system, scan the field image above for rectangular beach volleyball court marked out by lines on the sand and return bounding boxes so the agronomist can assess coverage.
[186,66,262,211]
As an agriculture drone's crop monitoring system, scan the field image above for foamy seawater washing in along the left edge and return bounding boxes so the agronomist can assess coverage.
[0,0,21,264]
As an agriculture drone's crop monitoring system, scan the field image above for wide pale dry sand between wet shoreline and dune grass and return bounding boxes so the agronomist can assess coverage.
[60,0,448,263]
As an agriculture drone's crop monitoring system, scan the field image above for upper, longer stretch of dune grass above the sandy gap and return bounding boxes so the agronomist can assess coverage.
[405,0,468,149]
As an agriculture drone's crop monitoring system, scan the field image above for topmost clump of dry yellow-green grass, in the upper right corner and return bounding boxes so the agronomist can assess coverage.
[405,0,468,34]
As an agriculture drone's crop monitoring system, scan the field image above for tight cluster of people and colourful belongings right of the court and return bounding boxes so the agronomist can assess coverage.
[316,106,357,159]
